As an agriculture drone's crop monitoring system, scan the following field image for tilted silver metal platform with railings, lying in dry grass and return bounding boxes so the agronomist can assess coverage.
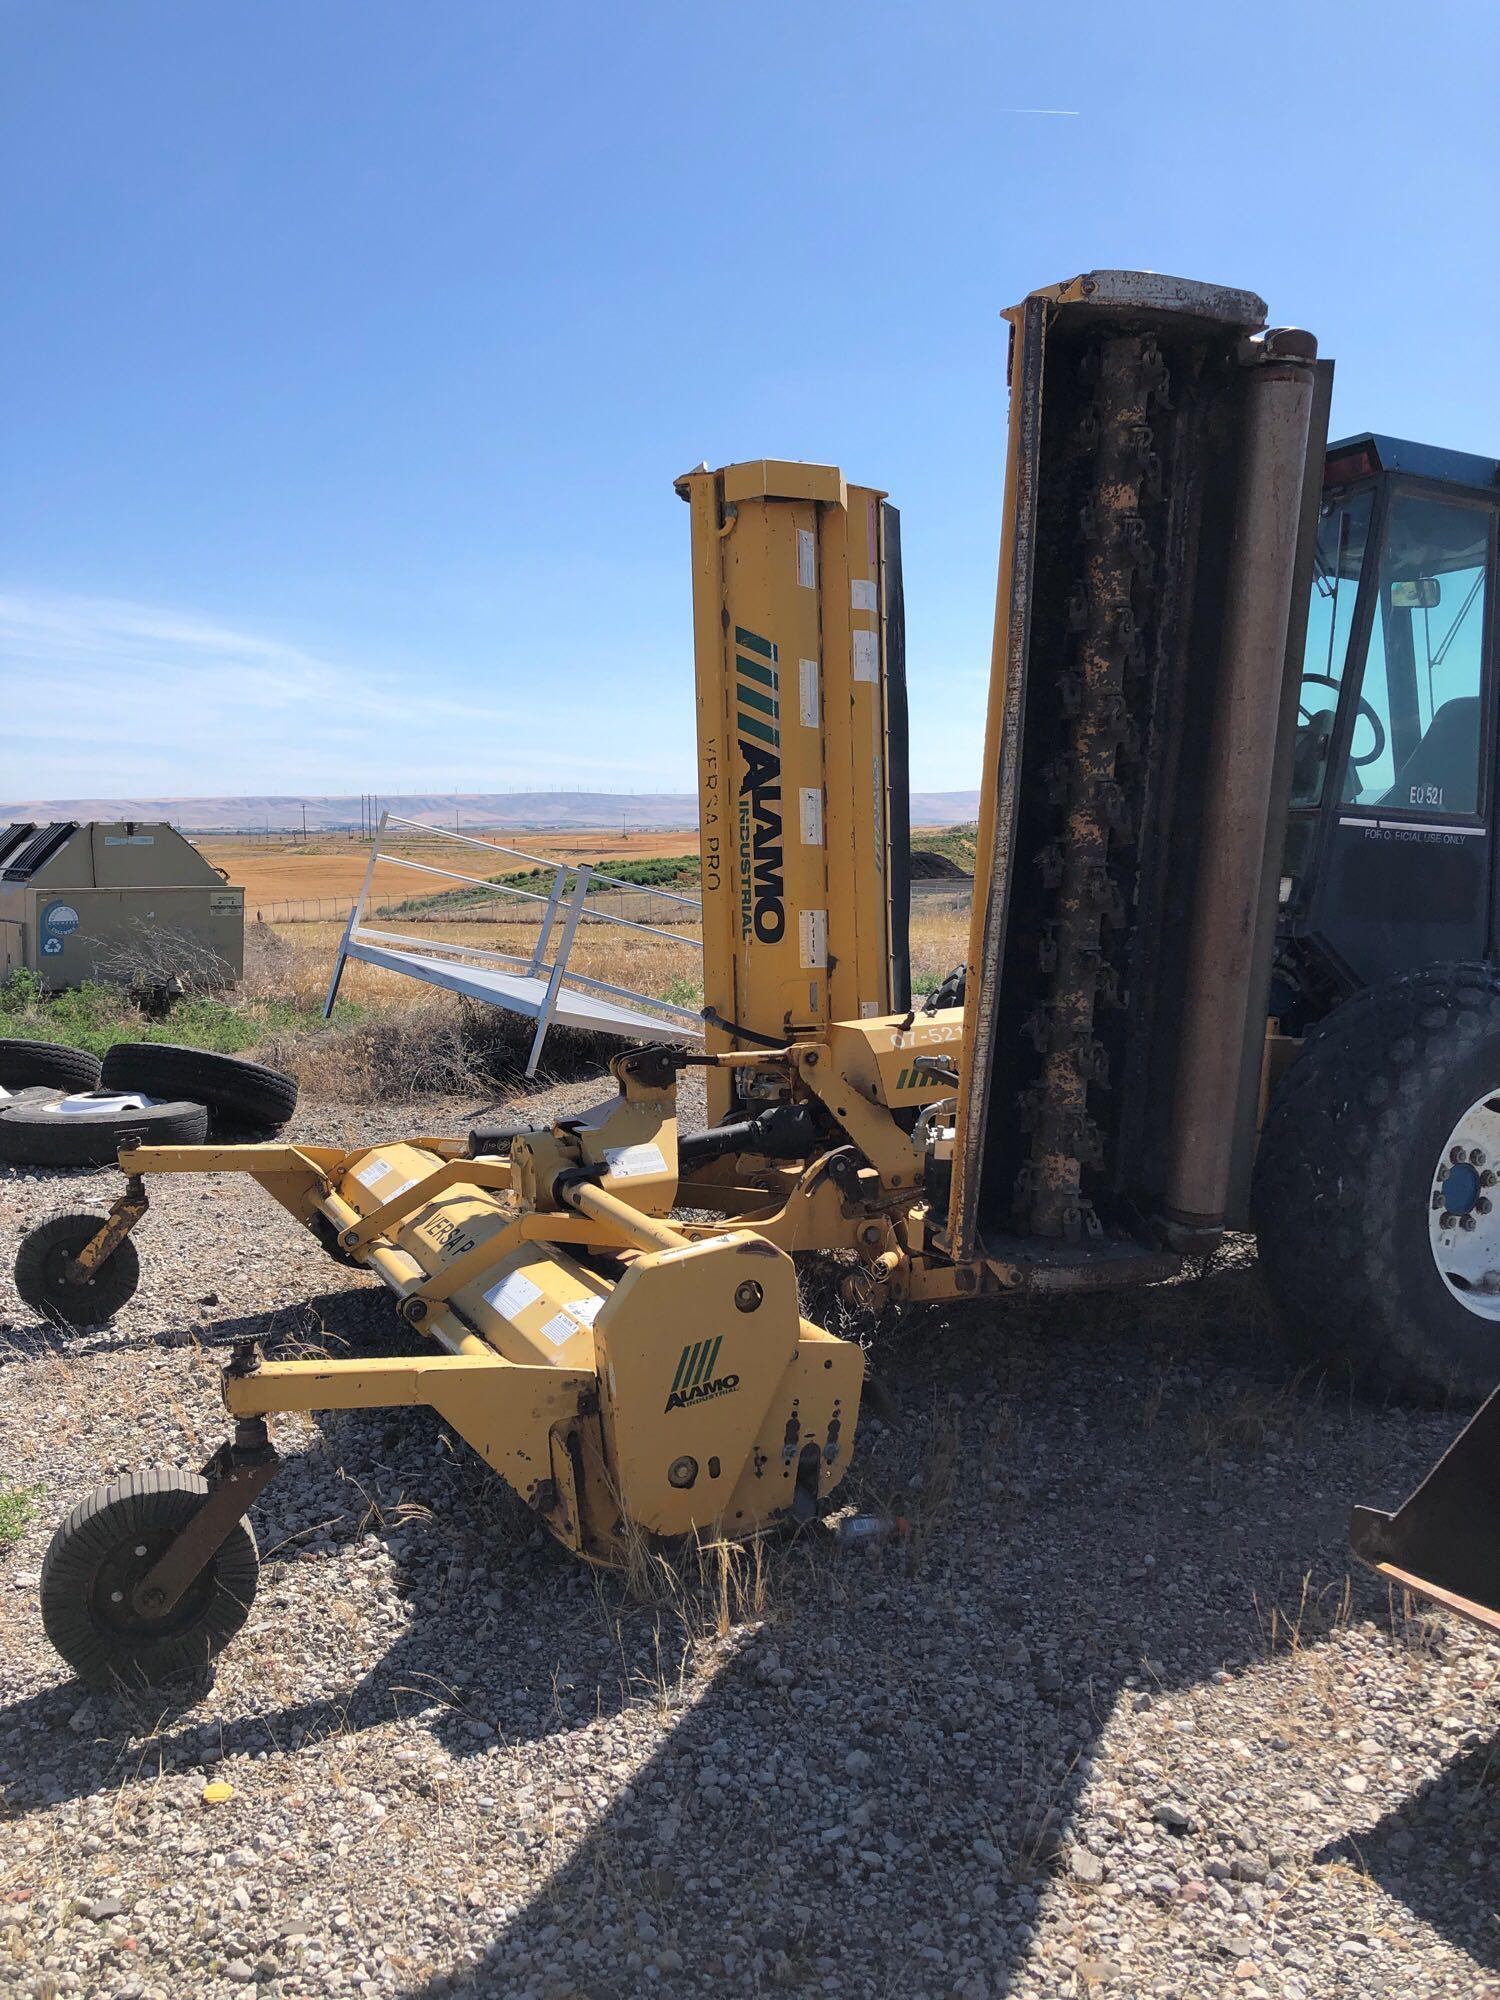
[322,812,702,1076]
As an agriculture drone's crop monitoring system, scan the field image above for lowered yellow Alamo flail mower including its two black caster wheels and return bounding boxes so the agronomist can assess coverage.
[22,1022,942,1684]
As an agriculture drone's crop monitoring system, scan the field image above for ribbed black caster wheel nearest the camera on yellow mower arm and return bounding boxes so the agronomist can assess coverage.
[40,1466,260,1688]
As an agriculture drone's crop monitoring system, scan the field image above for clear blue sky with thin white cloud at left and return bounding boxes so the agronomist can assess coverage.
[0,0,1500,798]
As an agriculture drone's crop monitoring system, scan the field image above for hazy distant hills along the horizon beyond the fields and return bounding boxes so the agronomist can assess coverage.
[0,792,980,834]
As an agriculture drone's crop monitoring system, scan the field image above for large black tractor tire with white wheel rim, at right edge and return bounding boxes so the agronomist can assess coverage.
[1250,964,1500,1404]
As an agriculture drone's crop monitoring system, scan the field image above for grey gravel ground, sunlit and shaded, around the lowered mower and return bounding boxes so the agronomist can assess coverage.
[0,1086,1500,2000]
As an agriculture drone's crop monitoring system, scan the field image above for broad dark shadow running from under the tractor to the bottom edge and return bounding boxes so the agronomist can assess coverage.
[384,1270,1496,2000]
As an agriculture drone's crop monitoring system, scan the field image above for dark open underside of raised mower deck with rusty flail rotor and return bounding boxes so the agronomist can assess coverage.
[946,272,1306,1260]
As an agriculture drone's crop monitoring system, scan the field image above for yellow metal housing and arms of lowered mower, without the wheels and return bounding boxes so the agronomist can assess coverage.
[132,1058,868,1562]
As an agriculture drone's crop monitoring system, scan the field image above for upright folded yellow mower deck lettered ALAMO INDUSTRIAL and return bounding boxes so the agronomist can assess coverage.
[678,460,894,1122]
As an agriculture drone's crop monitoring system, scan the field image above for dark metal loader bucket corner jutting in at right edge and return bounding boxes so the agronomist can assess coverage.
[1350,1390,1500,1632]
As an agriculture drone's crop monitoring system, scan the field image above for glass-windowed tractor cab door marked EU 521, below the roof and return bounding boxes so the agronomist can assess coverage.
[1288,478,1496,986]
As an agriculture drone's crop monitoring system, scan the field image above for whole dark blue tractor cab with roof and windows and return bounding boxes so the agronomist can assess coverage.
[1272,434,1500,1034]
